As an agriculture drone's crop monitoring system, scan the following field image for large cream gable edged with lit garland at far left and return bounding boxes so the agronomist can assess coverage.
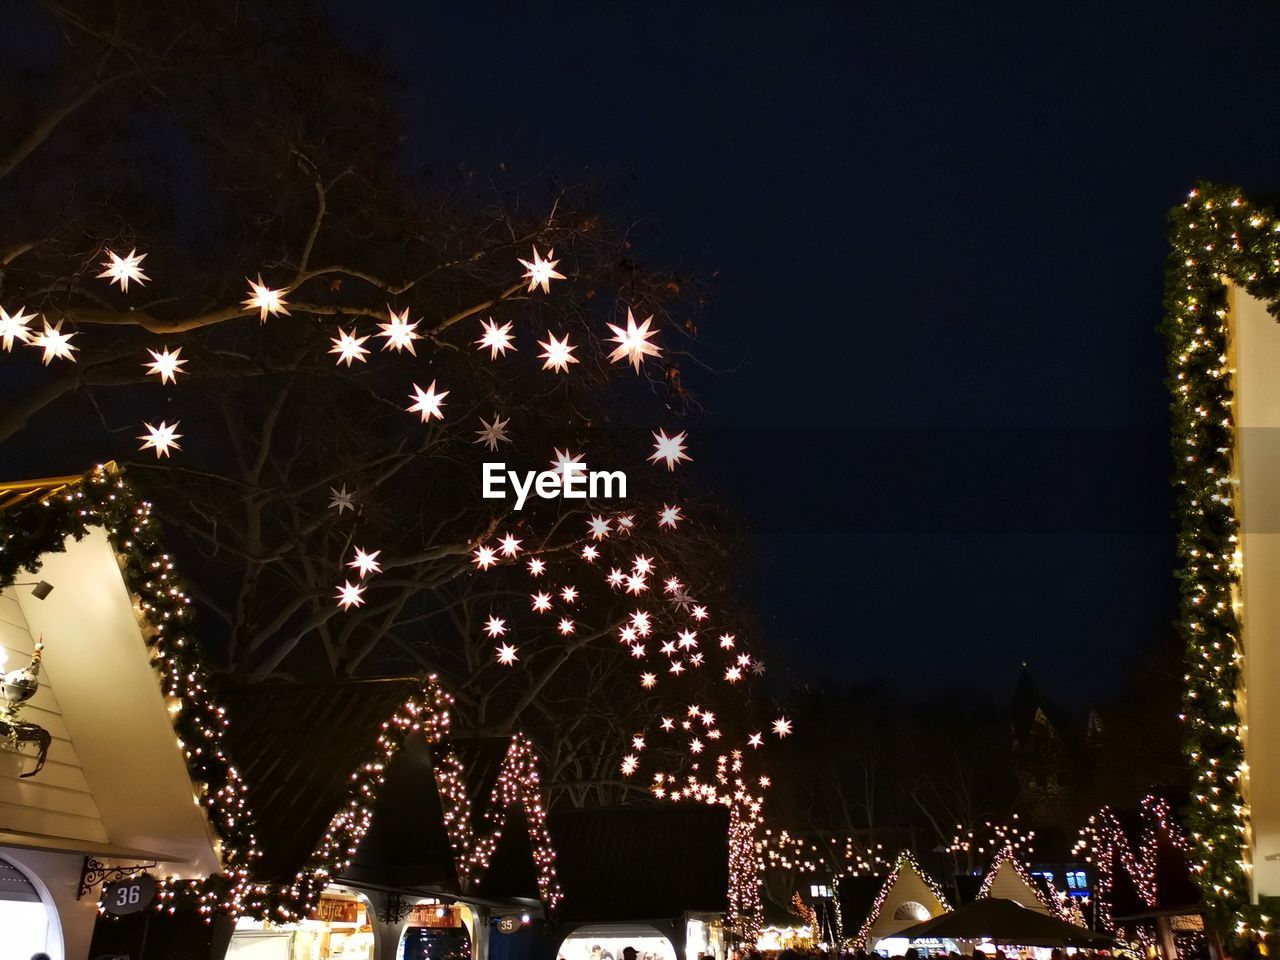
[0,465,253,905]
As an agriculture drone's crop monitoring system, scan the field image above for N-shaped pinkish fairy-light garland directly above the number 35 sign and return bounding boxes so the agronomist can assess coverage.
[435,735,564,910]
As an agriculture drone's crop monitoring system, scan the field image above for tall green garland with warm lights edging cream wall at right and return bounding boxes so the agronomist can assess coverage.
[1162,184,1280,940]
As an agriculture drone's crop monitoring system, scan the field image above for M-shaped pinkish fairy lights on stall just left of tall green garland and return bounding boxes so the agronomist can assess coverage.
[1071,796,1194,931]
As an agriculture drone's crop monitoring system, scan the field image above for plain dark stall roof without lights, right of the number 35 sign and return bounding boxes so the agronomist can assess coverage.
[549,803,728,923]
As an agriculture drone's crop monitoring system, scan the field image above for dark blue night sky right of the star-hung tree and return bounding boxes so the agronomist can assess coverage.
[312,1,1280,700]
